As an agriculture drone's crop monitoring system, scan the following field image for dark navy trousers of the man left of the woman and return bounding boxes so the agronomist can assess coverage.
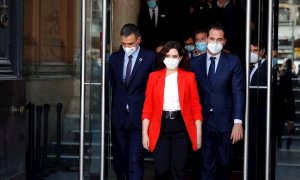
[112,114,144,180]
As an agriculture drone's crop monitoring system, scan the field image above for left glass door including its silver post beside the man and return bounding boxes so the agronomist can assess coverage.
[81,0,110,179]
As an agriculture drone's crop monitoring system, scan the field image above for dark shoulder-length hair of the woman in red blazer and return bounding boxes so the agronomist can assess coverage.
[157,41,190,71]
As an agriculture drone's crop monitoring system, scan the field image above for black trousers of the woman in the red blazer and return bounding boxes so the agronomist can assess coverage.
[153,114,191,180]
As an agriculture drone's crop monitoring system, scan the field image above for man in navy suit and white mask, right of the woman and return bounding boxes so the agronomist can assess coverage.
[191,24,245,180]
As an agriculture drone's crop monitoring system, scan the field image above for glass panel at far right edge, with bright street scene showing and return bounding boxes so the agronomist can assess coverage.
[274,0,300,180]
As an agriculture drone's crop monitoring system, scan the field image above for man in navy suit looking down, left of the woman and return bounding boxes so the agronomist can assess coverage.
[109,24,156,180]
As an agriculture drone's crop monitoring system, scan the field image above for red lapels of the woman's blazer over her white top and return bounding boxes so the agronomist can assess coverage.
[157,68,186,111]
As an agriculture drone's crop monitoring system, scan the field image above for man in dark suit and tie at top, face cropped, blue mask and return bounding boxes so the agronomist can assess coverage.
[138,0,170,50]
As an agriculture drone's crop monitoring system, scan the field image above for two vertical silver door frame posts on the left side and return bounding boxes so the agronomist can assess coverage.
[79,0,107,180]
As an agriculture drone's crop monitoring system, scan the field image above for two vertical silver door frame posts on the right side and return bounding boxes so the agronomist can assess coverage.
[243,0,278,180]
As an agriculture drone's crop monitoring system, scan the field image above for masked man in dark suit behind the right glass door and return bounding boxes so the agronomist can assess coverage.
[247,40,268,179]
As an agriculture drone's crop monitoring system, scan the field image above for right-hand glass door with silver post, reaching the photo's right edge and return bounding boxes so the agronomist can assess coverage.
[244,0,300,180]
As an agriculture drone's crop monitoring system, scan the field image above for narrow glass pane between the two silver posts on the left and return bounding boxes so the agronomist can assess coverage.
[84,0,102,179]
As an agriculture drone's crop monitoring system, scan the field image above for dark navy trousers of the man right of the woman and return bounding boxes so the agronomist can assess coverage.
[199,126,233,180]
